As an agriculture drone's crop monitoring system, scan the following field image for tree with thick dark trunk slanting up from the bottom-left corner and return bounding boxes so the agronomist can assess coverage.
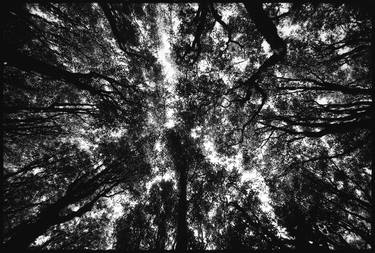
[5,135,153,248]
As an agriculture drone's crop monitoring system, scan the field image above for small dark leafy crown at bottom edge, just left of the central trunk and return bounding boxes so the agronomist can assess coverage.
[116,181,176,250]
